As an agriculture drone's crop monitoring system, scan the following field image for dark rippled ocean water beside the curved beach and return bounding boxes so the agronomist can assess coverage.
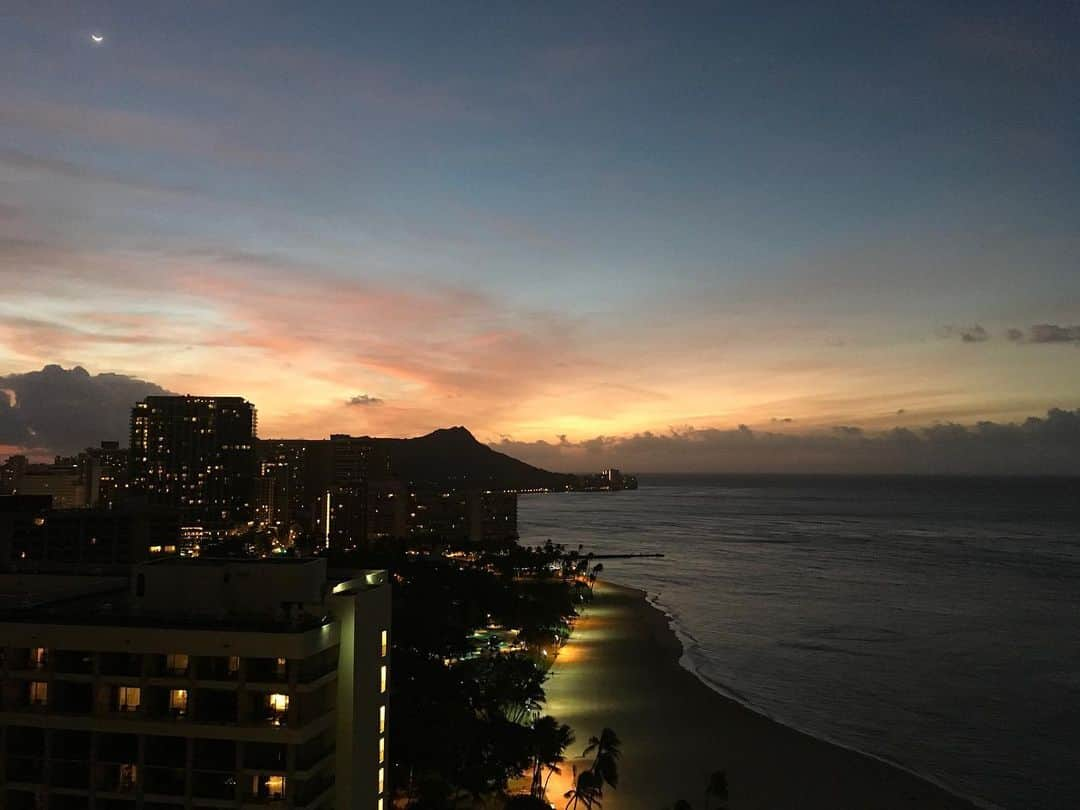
[518,475,1080,810]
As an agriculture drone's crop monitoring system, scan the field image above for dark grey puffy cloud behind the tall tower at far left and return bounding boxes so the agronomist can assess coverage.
[0,365,168,455]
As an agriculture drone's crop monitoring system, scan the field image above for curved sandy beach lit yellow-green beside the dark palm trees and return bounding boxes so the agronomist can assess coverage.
[545,582,973,810]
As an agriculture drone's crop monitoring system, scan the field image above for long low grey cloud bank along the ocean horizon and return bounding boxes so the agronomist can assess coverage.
[492,408,1080,475]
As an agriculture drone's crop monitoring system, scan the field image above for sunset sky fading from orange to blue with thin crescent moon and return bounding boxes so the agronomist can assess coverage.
[0,0,1080,470]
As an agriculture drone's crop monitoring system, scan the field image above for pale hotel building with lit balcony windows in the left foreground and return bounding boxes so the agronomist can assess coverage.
[0,558,391,810]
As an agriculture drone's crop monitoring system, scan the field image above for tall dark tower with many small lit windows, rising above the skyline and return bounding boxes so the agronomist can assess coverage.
[130,396,256,527]
